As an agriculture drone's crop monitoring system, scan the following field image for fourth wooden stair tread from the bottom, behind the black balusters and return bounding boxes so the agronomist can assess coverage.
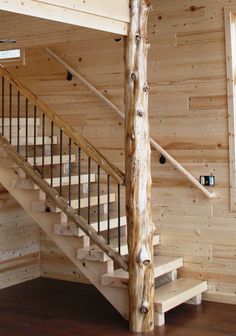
[54,216,126,237]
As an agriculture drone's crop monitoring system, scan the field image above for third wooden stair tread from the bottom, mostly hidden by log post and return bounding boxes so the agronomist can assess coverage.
[77,235,160,262]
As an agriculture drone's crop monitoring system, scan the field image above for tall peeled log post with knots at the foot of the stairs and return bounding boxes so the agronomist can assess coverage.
[125,0,154,332]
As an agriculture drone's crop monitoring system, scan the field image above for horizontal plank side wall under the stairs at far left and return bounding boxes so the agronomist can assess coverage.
[0,197,40,288]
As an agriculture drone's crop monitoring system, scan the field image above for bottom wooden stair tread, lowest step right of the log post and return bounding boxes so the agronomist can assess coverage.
[154,278,207,314]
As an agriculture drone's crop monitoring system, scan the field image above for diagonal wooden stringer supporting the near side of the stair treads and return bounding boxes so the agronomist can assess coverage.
[0,158,129,319]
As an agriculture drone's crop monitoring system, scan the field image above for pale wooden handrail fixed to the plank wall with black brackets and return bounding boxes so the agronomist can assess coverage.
[44,48,216,199]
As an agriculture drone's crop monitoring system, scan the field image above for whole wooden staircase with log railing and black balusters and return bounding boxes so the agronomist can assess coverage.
[0,69,207,326]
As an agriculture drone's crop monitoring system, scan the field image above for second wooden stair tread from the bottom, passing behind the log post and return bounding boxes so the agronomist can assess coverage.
[102,255,183,288]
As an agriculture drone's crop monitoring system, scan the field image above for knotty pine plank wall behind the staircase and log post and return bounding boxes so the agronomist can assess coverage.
[0,0,236,304]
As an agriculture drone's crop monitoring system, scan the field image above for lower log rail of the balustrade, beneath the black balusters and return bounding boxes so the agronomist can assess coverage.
[0,135,128,271]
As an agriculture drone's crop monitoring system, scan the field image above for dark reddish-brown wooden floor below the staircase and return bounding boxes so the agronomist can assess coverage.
[0,279,236,336]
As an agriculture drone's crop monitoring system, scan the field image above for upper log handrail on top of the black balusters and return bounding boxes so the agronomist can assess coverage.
[0,67,125,185]
